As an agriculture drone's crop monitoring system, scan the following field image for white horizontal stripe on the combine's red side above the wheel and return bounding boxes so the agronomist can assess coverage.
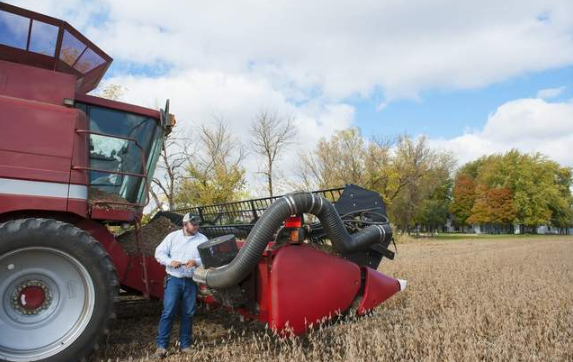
[0,178,88,200]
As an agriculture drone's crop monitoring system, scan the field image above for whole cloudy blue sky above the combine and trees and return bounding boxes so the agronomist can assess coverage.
[7,0,573,195]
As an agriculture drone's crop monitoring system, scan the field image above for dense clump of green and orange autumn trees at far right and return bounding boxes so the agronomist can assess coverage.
[450,150,573,233]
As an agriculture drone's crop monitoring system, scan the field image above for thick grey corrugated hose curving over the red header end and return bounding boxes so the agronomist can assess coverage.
[193,192,392,289]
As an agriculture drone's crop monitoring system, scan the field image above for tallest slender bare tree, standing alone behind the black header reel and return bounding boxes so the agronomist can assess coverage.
[250,110,297,196]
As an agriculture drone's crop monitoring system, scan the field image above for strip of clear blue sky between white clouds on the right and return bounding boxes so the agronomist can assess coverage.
[351,66,573,138]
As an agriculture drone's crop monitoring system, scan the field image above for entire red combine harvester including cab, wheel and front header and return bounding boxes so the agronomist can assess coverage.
[0,3,403,362]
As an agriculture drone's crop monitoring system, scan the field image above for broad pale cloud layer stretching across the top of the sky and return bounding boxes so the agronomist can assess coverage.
[5,0,573,101]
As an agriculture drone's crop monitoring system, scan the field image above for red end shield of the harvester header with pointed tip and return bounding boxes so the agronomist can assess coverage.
[192,243,401,335]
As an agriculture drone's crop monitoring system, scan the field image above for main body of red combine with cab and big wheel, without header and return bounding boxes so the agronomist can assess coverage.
[0,3,174,362]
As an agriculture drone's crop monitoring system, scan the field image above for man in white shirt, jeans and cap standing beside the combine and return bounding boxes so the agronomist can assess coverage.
[155,214,207,358]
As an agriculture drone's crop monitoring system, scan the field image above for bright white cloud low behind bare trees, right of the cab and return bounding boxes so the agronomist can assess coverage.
[103,70,354,195]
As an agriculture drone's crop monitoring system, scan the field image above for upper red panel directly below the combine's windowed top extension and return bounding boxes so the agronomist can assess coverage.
[0,60,76,105]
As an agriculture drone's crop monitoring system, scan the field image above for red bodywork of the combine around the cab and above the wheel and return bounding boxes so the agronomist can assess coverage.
[0,54,170,297]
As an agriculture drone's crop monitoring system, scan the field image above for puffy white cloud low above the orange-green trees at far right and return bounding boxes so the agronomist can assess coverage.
[431,98,573,166]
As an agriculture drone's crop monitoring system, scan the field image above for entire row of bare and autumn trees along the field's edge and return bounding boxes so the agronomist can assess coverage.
[152,119,573,233]
